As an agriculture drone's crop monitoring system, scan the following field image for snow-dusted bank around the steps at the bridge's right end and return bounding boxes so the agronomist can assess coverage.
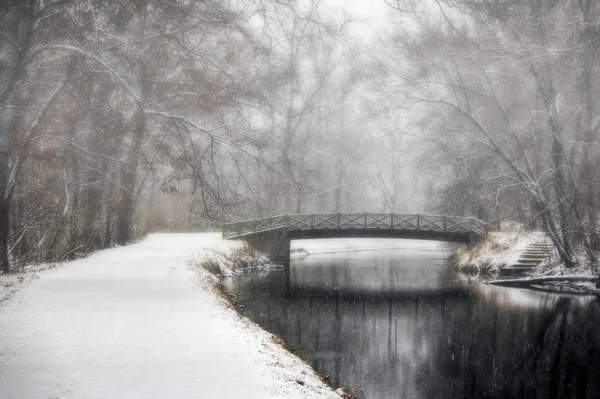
[450,230,600,293]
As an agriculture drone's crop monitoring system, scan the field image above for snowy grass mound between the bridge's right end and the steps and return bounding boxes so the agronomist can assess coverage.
[452,231,544,273]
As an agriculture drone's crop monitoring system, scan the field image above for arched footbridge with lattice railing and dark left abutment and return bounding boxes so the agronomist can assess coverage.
[223,212,486,262]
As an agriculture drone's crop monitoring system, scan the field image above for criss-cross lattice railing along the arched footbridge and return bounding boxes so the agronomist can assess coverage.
[223,212,486,238]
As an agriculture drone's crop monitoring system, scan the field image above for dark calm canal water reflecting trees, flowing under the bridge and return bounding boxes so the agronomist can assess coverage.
[225,242,600,398]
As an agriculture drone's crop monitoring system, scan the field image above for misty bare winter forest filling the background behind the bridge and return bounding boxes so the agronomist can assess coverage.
[0,0,600,273]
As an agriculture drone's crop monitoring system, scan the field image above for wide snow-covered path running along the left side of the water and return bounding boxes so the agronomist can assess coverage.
[0,234,338,399]
